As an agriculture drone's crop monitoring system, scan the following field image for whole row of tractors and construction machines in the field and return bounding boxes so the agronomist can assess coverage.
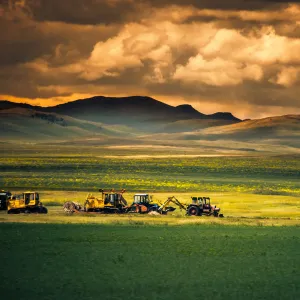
[0,189,223,217]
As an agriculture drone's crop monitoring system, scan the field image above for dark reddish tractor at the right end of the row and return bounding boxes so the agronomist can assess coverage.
[186,197,223,218]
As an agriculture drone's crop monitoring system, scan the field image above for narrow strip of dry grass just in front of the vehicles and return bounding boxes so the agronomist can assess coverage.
[0,206,300,227]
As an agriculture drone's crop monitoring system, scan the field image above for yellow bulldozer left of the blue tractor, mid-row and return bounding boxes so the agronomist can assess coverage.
[83,189,127,213]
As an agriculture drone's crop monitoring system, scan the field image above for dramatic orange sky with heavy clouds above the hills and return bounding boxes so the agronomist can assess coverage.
[0,0,300,118]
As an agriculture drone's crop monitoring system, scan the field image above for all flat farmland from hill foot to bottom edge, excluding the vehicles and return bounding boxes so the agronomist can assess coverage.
[0,146,300,300]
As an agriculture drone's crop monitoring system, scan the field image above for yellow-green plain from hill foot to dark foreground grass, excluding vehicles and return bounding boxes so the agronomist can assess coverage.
[0,144,300,225]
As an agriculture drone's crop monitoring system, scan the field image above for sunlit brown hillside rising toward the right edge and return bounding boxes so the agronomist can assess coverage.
[142,115,300,153]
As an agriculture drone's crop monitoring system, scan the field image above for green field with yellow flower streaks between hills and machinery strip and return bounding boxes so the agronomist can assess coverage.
[0,146,300,196]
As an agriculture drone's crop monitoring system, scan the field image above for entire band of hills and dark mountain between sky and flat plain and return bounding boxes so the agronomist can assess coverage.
[0,96,300,153]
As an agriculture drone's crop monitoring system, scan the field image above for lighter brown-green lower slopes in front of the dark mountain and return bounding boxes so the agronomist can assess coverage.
[0,101,300,153]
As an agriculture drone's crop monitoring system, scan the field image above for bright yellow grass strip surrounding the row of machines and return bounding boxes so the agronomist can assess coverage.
[0,191,300,226]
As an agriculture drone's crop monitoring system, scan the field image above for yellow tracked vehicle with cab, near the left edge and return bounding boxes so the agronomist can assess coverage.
[7,192,48,214]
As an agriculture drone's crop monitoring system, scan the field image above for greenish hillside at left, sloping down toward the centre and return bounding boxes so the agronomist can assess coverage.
[0,107,138,142]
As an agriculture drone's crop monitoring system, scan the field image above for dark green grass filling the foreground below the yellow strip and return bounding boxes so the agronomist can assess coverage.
[0,223,300,300]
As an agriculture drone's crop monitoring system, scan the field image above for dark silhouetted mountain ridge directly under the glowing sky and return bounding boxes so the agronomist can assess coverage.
[0,96,240,131]
